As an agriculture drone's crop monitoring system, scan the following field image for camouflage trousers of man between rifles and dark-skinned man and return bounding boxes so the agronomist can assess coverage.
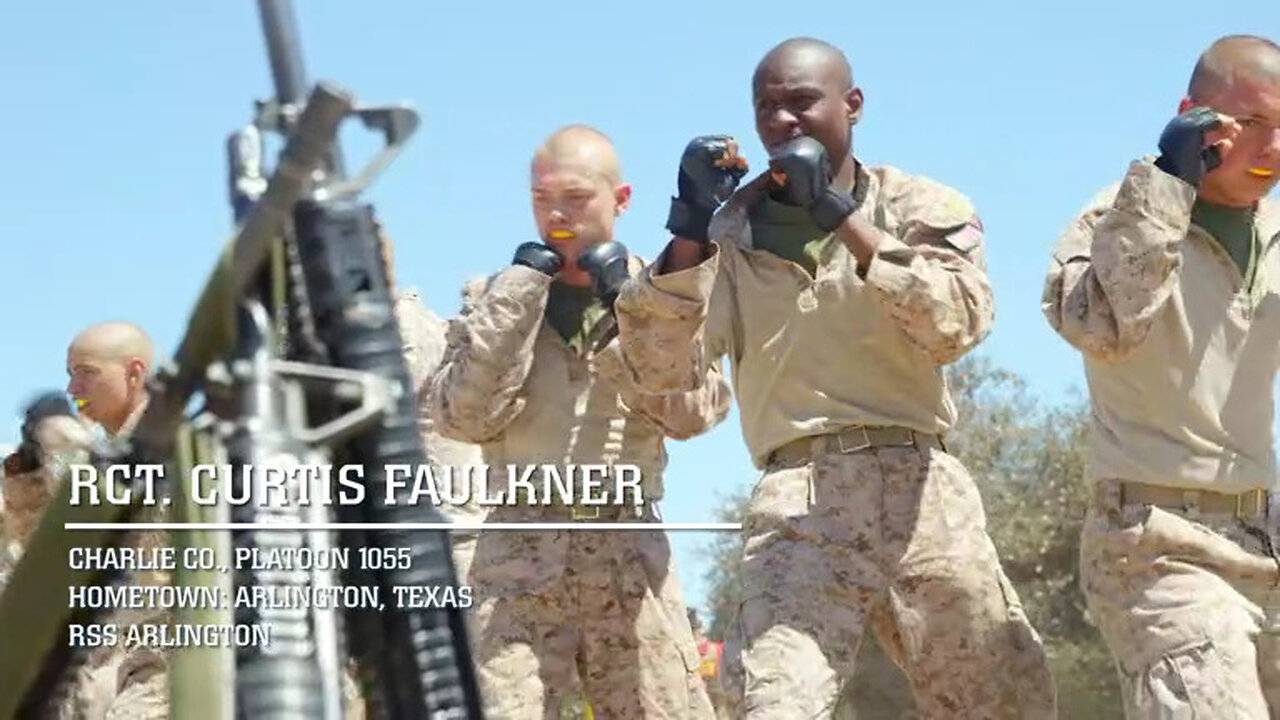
[468,507,713,720]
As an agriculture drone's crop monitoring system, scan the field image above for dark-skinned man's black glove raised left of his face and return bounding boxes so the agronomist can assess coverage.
[667,135,748,242]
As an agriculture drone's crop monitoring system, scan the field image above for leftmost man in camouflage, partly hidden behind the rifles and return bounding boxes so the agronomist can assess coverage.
[0,323,169,720]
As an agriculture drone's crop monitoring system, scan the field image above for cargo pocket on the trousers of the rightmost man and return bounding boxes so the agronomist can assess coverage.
[1133,641,1236,720]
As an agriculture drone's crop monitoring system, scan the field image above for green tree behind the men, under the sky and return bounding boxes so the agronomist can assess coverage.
[704,356,1123,720]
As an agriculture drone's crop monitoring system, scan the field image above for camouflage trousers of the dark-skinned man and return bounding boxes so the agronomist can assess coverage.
[724,446,1057,720]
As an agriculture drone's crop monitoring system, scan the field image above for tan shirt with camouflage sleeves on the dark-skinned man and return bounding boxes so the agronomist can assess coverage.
[617,160,995,468]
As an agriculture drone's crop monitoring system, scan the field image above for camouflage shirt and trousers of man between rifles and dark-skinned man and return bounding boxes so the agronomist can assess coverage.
[430,252,731,719]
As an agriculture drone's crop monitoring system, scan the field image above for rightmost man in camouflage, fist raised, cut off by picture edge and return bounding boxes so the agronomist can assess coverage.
[1043,37,1280,719]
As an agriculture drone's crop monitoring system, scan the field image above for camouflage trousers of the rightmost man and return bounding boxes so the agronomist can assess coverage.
[1080,482,1280,720]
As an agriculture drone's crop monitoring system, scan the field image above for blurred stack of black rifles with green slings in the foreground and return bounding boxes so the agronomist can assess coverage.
[0,0,481,720]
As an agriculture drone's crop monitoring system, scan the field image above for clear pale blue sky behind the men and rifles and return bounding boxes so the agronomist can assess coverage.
[0,0,1280,614]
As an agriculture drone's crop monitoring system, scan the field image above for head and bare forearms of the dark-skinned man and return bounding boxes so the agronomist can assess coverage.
[657,38,884,274]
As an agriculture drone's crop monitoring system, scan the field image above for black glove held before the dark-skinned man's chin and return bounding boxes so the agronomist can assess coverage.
[769,136,858,232]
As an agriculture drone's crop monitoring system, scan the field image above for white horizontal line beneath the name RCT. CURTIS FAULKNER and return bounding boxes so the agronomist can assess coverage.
[63,520,742,532]
